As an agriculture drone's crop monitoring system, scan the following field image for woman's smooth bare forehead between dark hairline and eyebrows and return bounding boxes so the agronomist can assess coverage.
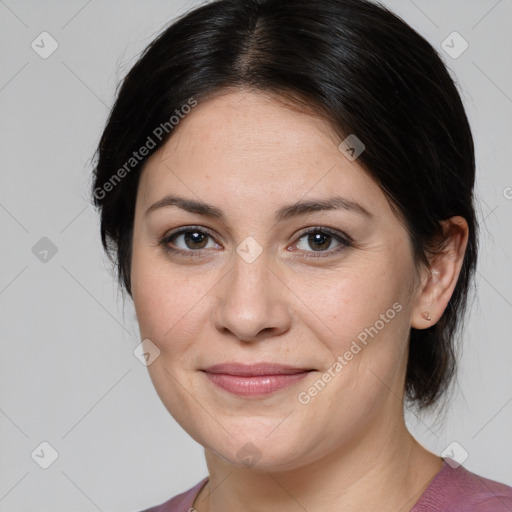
[136,91,386,218]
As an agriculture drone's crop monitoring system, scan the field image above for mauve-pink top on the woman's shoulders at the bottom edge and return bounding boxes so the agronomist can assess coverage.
[142,458,512,512]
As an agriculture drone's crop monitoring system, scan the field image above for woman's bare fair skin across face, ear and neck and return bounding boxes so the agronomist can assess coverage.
[131,89,468,512]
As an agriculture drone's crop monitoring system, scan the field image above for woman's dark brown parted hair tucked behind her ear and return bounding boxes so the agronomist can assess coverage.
[93,0,478,409]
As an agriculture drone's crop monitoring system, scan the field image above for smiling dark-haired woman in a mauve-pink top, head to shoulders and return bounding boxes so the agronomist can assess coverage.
[94,0,512,512]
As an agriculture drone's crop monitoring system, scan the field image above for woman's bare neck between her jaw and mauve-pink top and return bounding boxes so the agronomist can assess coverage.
[194,417,442,512]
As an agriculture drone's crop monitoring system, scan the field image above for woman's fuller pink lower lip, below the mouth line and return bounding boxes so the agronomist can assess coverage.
[206,372,309,396]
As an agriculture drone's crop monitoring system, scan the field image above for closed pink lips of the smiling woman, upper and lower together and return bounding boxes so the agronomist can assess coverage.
[203,362,313,397]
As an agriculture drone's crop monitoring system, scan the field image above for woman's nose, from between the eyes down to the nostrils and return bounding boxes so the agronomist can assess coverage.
[215,246,293,342]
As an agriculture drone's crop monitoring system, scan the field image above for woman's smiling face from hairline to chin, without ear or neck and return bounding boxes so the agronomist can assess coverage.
[131,91,424,469]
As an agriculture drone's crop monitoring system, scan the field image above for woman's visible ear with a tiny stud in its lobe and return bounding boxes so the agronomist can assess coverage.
[411,216,469,329]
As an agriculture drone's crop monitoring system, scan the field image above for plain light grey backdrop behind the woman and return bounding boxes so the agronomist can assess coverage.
[0,0,512,512]
